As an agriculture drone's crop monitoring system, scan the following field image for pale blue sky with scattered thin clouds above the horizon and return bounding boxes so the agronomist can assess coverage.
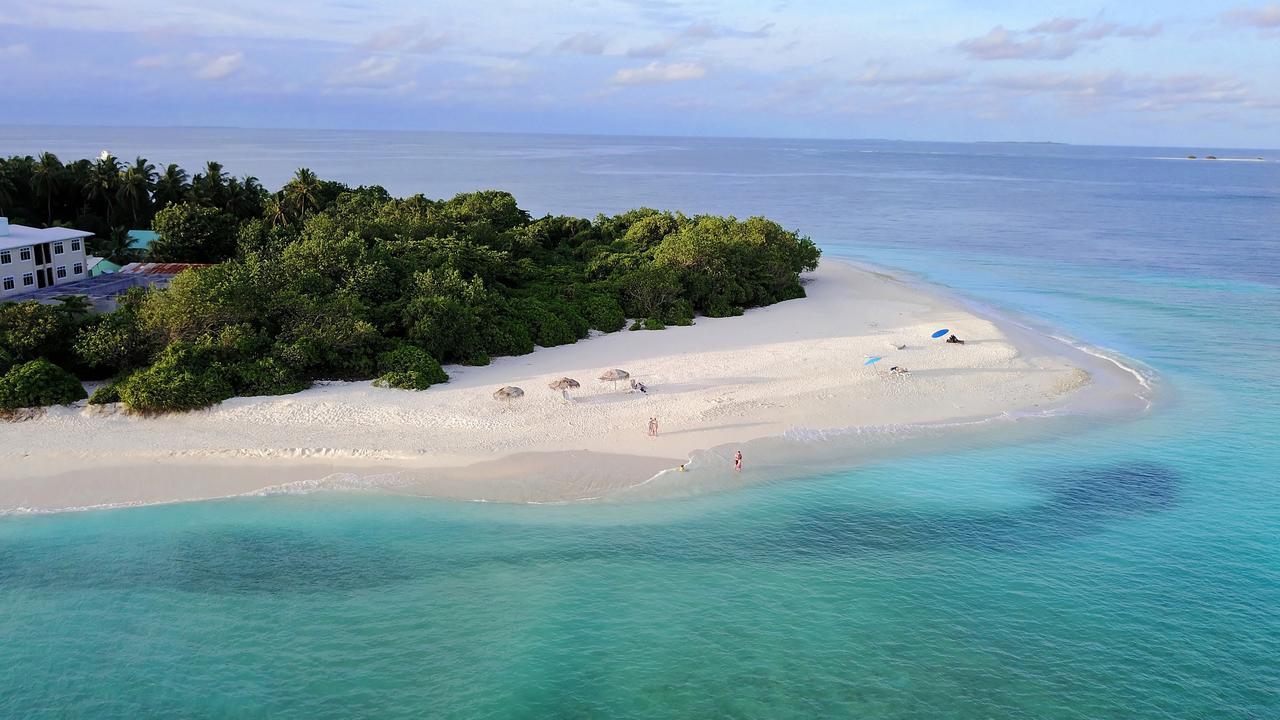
[0,0,1280,147]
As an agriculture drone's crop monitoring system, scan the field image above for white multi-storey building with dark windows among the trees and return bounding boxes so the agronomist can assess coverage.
[0,218,93,300]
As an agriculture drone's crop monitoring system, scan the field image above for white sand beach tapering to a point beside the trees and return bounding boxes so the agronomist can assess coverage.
[0,260,1138,512]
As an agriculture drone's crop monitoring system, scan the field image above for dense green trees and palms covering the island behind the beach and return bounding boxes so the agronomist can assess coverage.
[0,152,819,413]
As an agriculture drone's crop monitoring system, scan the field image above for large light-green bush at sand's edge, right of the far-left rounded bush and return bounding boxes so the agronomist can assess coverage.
[120,342,236,413]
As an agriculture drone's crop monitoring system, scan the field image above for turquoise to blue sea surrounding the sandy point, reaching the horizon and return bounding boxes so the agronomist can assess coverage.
[0,131,1280,719]
